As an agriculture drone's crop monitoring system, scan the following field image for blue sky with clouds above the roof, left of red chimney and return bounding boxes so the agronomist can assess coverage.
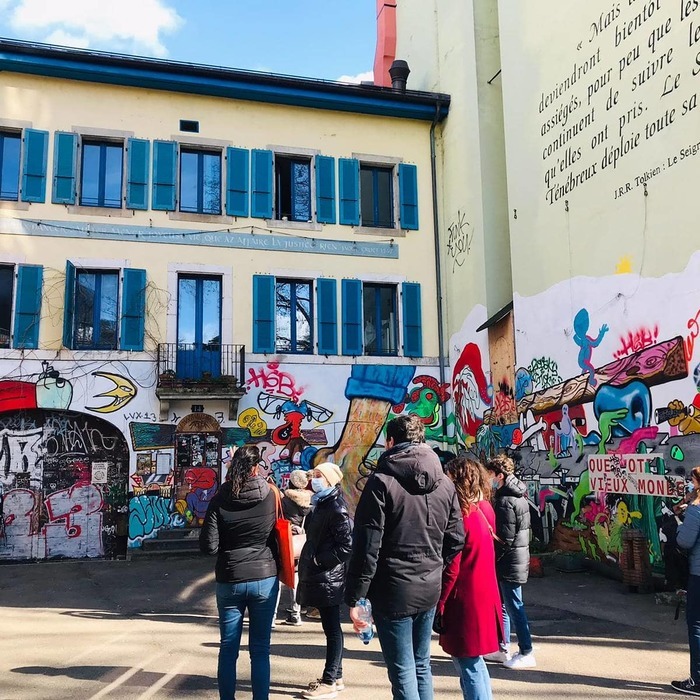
[0,0,376,80]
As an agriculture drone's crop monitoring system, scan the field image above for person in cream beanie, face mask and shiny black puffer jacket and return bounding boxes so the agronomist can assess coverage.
[297,462,352,698]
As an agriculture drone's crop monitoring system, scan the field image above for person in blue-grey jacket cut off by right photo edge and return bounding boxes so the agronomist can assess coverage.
[671,467,700,696]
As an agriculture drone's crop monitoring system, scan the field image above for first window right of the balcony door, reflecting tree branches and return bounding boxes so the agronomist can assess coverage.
[275,279,314,353]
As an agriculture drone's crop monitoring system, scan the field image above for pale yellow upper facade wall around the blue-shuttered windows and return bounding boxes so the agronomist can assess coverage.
[0,73,438,357]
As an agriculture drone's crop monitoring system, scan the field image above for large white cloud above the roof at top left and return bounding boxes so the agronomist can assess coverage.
[8,0,183,56]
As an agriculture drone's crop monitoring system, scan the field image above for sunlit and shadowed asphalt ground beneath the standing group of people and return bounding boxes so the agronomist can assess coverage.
[0,557,688,700]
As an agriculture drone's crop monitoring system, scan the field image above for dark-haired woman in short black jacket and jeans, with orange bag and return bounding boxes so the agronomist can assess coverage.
[199,445,279,700]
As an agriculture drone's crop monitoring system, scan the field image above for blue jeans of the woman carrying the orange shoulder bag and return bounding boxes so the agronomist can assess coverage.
[216,576,279,700]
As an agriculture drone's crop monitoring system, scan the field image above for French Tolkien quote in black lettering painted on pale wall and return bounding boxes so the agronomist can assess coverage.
[539,0,700,205]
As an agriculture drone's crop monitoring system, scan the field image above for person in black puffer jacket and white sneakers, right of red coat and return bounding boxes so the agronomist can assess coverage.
[486,455,537,669]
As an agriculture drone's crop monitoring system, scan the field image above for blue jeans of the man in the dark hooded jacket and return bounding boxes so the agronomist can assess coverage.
[374,608,435,700]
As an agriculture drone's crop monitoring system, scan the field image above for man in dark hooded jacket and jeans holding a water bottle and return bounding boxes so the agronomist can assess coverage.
[345,415,464,700]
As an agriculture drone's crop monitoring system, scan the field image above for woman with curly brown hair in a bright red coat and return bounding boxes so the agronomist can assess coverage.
[437,457,503,700]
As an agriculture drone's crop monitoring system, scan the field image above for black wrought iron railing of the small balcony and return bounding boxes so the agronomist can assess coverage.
[158,343,245,389]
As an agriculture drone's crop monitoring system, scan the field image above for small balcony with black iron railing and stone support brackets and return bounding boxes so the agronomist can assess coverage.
[156,343,246,420]
